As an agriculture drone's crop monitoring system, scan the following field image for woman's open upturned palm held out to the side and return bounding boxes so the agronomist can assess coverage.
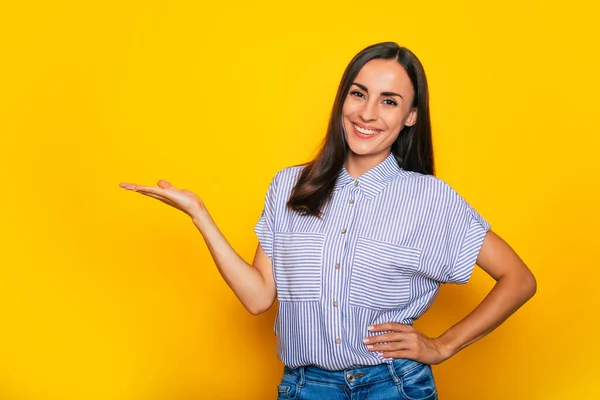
[119,179,205,219]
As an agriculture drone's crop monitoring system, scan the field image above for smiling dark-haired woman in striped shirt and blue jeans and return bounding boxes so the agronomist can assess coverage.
[121,43,536,399]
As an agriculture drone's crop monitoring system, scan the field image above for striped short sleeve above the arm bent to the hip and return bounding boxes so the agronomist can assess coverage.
[443,188,491,284]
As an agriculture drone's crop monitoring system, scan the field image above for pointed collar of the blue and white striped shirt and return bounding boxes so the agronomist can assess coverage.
[333,153,402,199]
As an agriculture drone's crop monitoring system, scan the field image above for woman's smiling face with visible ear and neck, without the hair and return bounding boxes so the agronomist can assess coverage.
[342,59,417,165]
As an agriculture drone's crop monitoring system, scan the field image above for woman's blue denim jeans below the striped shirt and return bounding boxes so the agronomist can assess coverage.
[277,359,438,400]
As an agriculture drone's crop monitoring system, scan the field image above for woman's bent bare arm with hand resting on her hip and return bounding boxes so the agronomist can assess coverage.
[365,231,537,364]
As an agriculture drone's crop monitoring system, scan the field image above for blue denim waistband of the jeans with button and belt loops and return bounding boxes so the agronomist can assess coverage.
[283,358,421,387]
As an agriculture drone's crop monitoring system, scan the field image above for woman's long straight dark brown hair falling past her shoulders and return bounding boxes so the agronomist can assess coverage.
[287,42,435,217]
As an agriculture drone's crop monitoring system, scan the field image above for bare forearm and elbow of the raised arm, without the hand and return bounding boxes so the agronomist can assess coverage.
[192,210,276,315]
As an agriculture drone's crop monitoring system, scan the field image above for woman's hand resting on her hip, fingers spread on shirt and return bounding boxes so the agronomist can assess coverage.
[363,322,452,365]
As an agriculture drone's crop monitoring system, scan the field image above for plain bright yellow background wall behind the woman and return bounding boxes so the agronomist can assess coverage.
[0,0,600,400]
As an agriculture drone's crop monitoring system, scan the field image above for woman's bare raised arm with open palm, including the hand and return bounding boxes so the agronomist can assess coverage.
[119,180,276,314]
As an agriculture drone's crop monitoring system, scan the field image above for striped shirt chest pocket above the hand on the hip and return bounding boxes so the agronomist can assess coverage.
[350,238,421,310]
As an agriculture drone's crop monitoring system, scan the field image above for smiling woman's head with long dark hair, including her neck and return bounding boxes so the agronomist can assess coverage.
[289,43,434,216]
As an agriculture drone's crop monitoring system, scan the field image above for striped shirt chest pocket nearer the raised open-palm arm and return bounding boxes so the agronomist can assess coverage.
[273,232,325,301]
